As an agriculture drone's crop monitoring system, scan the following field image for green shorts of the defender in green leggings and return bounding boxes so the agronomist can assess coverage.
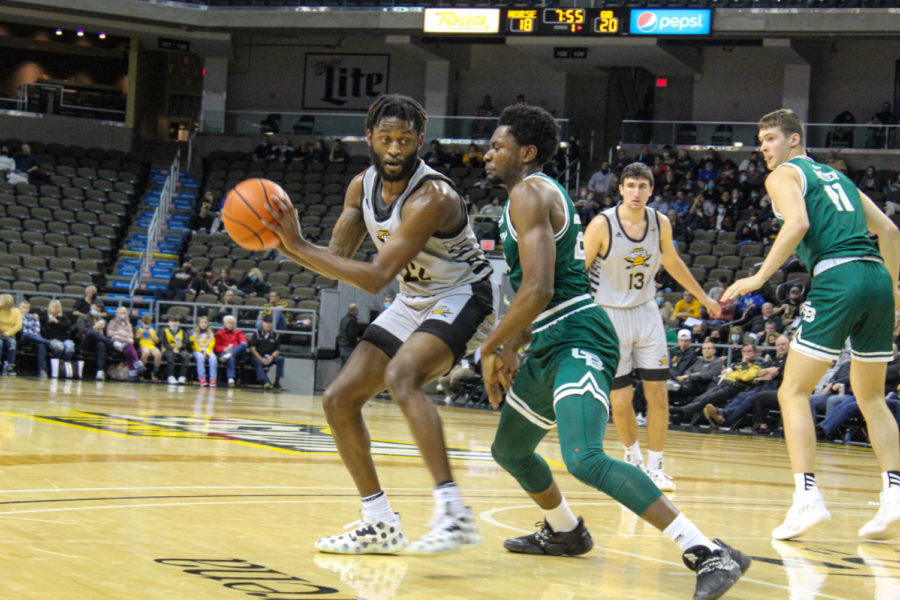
[506,295,619,429]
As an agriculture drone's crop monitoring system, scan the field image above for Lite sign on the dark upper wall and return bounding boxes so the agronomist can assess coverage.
[303,53,391,112]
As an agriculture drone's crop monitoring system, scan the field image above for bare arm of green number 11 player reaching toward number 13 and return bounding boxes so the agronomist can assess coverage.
[722,168,809,301]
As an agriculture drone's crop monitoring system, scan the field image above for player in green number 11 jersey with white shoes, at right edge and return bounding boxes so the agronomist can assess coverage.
[723,110,900,539]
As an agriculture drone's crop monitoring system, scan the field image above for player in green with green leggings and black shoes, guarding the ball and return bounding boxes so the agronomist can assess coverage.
[479,105,750,600]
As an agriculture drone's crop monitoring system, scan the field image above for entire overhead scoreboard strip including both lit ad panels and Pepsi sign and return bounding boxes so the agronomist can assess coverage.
[424,7,712,37]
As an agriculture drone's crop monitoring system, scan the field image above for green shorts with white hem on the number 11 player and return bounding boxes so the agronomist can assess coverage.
[791,260,894,362]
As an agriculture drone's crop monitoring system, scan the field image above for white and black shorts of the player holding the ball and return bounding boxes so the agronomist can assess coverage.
[362,279,500,360]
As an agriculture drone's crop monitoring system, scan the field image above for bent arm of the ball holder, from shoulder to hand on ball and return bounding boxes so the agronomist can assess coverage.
[263,182,454,294]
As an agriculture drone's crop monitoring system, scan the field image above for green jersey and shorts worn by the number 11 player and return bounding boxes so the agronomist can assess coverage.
[773,156,894,362]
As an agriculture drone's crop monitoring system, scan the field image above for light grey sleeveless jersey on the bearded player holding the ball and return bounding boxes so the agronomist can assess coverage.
[360,160,492,296]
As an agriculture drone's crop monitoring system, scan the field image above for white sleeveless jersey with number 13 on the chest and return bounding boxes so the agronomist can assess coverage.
[590,207,662,308]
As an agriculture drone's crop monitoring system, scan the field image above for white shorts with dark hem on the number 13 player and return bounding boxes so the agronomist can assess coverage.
[603,299,669,389]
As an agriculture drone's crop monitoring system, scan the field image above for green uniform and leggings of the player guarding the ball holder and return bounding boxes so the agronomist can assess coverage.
[491,174,661,514]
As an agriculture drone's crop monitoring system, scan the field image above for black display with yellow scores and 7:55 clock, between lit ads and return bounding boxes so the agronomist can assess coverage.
[504,8,629,36]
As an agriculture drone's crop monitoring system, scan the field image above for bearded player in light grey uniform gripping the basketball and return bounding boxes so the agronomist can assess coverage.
[264,95,499,555]
